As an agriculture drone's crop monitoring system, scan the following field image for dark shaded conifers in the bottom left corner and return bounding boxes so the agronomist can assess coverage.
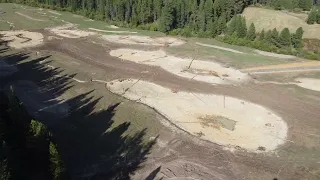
[0,90,68,180]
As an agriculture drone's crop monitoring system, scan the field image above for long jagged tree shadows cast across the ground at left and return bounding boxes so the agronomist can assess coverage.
[0,39,155,179]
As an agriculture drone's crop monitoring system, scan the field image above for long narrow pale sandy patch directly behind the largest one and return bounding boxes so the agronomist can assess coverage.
[110,49,250,84]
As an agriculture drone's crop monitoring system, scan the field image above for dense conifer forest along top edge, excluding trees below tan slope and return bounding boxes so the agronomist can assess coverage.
[1,0,318,36]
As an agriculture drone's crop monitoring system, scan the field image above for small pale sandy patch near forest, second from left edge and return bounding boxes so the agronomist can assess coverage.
[47,23,96,38]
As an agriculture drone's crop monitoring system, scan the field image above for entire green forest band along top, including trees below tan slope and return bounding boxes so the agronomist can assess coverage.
[0,0,320,59]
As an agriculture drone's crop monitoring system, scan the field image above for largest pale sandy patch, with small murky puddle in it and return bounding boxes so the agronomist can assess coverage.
[108,80,288,151]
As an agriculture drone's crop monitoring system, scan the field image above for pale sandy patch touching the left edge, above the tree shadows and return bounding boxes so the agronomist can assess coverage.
[0,30,43,49]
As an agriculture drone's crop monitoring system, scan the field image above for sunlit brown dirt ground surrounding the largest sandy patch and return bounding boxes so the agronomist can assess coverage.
[1,27,320,180]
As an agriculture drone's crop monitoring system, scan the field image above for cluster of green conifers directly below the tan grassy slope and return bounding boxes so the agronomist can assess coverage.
[218,15,320,59]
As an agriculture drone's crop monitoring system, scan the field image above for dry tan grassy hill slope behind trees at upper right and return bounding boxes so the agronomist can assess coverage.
[243,7,320,39]
